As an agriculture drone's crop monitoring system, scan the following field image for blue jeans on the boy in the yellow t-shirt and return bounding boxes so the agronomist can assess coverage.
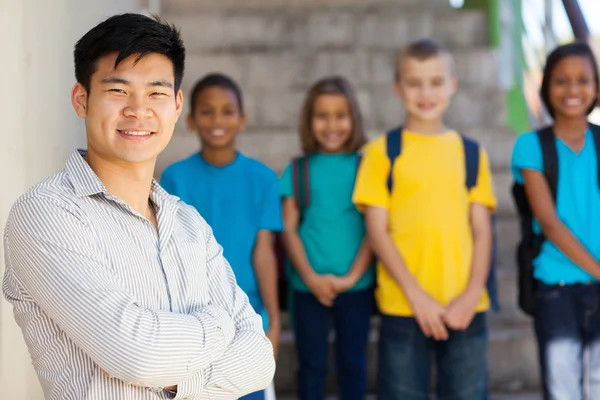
[378,313,488,400]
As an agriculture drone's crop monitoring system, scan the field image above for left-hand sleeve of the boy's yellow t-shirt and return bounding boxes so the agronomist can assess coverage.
[352,138,390,209]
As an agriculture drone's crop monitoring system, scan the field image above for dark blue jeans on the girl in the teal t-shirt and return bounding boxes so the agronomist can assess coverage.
[294,289,375,400]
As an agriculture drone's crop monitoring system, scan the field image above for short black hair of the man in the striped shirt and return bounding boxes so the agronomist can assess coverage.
[73,13,185,93]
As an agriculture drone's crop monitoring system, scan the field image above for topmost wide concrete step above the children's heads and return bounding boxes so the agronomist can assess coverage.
[163,5,489,54]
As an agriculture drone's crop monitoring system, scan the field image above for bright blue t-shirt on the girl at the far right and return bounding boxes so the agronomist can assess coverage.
[512,130,600,285]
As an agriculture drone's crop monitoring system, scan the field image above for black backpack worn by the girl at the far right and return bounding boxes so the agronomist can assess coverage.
[512,124,600,316]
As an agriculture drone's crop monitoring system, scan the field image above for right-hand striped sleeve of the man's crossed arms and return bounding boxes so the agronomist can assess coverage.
[175,214,275,400]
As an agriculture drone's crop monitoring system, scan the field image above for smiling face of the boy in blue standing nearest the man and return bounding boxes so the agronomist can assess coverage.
[187,86,246,149]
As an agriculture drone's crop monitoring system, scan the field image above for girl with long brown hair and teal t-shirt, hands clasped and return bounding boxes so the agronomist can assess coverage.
[280,77,374,400]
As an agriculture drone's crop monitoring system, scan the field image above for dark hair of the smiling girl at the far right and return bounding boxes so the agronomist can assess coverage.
[540,42,600,117]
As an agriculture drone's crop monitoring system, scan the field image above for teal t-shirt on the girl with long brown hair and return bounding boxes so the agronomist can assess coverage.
[279,153,375,292]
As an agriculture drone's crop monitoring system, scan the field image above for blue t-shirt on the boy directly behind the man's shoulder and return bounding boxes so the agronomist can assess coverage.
[160,153,283,323]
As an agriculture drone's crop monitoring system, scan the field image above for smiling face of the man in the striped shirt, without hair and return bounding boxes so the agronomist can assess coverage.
[72,53,183,164]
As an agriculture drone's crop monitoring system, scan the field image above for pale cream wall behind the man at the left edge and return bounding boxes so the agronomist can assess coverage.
[0,0,138,400]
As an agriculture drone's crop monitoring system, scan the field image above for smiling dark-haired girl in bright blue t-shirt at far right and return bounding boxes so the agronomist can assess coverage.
[512,43,600,400]
